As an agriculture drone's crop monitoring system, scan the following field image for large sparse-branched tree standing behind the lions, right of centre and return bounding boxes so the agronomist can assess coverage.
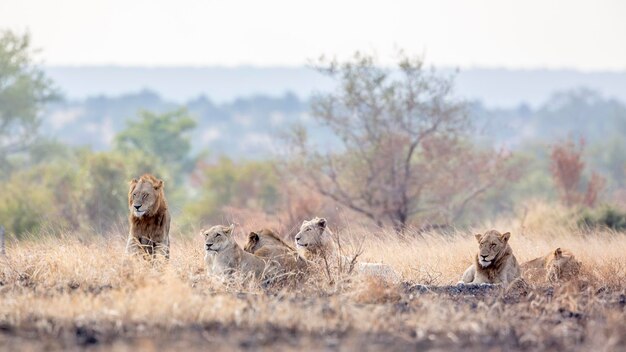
[289,53,516,230]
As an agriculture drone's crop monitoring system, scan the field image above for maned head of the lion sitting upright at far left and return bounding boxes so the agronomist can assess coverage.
[128,174,165,218]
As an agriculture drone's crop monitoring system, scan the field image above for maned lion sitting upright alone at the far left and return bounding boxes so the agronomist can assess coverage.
[126,174,171,259]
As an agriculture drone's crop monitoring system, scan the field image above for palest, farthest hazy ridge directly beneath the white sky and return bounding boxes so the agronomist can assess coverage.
[45,66,626,108]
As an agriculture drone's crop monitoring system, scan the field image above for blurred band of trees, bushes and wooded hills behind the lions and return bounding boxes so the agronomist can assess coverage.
[0,31,626,238]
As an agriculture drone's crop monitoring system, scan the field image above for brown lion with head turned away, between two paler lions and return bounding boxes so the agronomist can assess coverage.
[243,229,311,272]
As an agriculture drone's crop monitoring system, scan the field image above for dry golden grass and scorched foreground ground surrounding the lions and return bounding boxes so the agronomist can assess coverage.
[0,212,626,351]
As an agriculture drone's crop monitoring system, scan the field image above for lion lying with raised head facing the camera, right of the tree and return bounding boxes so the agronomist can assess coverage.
[460,230,520,285]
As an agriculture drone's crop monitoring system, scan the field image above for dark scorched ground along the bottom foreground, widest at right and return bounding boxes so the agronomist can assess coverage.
[0,283,626,351]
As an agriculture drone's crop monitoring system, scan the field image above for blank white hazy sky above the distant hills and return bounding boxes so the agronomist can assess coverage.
[0,0,626,70]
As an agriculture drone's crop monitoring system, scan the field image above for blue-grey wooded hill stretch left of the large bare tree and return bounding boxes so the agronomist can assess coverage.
[43,90,336,158]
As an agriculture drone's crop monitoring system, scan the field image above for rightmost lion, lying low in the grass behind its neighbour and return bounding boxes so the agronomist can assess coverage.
[522,248,582,283]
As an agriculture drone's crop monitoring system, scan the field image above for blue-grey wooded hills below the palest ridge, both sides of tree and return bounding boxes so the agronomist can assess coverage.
[43,89,626,158]
